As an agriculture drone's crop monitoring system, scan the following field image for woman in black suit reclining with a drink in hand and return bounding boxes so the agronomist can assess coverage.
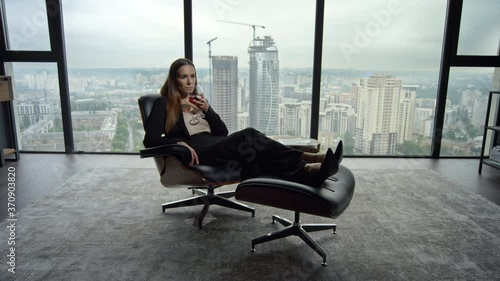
[144,58,340,186]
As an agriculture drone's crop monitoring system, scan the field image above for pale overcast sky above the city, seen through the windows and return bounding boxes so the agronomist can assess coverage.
[5,0,500,70]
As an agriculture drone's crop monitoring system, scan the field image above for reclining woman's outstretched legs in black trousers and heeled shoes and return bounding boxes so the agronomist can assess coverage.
[197,128,339,186]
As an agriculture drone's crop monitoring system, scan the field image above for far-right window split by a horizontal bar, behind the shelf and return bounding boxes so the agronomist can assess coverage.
[440,0,500,156]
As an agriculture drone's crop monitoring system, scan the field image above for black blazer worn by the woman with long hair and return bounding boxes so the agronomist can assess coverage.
[143,96,228,147]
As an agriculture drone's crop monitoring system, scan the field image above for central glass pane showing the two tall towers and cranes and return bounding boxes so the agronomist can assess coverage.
[193,0,315,137]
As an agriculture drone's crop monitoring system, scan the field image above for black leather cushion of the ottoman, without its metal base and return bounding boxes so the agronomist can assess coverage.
[235,165,355,218]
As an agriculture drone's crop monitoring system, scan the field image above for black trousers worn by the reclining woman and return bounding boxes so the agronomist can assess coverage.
[189,128,306,180]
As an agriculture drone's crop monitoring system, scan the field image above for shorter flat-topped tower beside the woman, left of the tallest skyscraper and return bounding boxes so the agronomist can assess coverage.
[210,56,238,133]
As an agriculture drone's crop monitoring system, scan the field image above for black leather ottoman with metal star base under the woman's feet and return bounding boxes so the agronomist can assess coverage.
[235,165,355,265]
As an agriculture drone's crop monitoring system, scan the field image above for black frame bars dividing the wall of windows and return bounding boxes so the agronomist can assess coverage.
[0,0,500,155]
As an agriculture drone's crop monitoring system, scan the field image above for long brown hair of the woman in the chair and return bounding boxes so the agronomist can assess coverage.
[160,58,198,134]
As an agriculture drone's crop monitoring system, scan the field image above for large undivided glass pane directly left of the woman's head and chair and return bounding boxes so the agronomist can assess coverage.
[63,0,184,152]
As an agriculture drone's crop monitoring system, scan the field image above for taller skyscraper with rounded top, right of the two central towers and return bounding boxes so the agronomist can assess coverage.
[248,36,279,135]
